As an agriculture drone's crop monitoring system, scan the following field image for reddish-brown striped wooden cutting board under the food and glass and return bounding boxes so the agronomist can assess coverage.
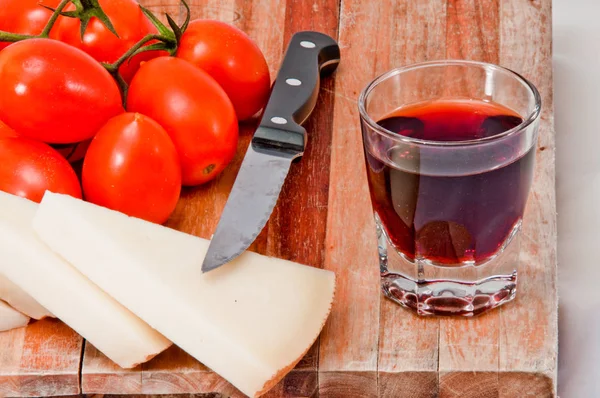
[0,0,557,398]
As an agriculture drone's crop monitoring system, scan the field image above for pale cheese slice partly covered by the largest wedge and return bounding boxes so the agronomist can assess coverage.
[0,192,171,368]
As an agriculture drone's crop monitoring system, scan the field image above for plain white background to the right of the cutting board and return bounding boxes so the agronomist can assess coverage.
[542,0,600,398]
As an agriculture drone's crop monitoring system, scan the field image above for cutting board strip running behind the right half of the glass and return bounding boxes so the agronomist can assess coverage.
[438,0,501,398]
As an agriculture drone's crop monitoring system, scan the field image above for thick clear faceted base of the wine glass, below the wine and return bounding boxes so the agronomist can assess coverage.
[375,215,521,316]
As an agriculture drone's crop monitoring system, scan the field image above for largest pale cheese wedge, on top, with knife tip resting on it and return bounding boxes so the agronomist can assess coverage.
[33,193,335,397]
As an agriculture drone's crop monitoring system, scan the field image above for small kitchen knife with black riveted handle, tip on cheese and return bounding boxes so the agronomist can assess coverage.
[202,31,340,272]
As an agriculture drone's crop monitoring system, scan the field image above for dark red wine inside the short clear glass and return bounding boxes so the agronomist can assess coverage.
[365,100,535,265]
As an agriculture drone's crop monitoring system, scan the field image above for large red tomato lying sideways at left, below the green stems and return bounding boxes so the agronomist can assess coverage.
[0,39,123,144]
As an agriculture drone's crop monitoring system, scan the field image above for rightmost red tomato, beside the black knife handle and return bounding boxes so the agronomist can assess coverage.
[177,20,271,120]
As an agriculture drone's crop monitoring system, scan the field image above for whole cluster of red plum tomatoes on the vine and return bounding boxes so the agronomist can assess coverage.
[0,0,271,223]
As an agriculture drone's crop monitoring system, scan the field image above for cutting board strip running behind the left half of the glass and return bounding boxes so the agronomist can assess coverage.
[369,0,448,398]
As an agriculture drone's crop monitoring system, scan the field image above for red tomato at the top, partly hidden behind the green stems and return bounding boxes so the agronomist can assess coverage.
[50,0,161,83]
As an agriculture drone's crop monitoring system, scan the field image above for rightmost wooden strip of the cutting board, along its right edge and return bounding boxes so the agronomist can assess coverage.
[499,0,558,398]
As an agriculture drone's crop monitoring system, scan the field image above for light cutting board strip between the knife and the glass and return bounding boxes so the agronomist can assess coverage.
[319,0,380,398]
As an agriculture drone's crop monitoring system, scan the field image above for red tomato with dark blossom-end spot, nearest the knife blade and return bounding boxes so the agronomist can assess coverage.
[127,57,238,185]
